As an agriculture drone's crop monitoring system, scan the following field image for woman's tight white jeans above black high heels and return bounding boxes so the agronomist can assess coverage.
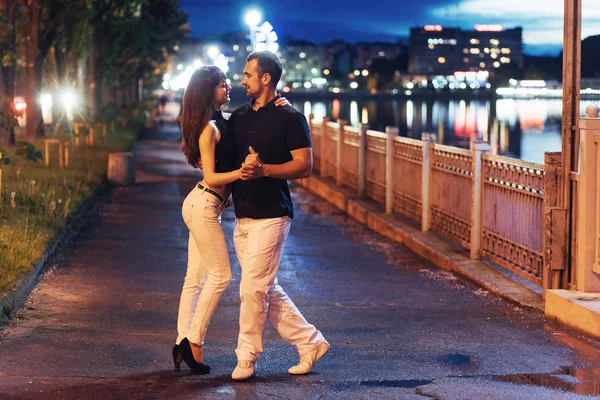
[176,186,231,344]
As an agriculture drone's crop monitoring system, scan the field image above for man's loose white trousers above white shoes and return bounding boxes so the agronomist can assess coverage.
[233,217,325,361]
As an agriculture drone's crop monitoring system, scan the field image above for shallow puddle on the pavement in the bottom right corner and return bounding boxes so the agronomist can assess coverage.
[493,367,600,395]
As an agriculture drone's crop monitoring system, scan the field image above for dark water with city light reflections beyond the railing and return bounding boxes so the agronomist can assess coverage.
[293,98,587,163]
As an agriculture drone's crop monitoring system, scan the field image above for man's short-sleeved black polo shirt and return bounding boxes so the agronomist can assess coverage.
[229,99,311,219]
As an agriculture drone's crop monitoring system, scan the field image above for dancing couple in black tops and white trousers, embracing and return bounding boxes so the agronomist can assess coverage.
[173,51,329,380]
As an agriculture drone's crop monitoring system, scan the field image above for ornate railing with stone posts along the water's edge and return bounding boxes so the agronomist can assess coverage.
[310,117,545,285]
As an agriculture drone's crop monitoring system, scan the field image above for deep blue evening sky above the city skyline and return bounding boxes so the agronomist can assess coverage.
[180,0,600,54]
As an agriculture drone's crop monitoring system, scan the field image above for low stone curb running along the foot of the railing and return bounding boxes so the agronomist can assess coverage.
[294,176,544,311]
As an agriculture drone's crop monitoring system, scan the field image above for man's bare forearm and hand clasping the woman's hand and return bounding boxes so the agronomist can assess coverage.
[240,147,312,180]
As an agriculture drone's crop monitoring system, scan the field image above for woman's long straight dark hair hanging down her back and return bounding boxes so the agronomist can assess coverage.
[181,66,227,168]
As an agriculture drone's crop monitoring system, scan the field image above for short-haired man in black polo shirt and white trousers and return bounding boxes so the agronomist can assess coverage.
[230,51,329,380]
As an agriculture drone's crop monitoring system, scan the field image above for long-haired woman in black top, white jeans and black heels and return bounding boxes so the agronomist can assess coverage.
[173,66,290,374]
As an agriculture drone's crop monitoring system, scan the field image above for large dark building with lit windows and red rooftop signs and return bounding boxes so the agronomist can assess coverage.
[408,25,523,76]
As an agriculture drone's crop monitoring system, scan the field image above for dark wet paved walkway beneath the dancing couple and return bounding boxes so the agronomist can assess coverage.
[0,125,600,400]
